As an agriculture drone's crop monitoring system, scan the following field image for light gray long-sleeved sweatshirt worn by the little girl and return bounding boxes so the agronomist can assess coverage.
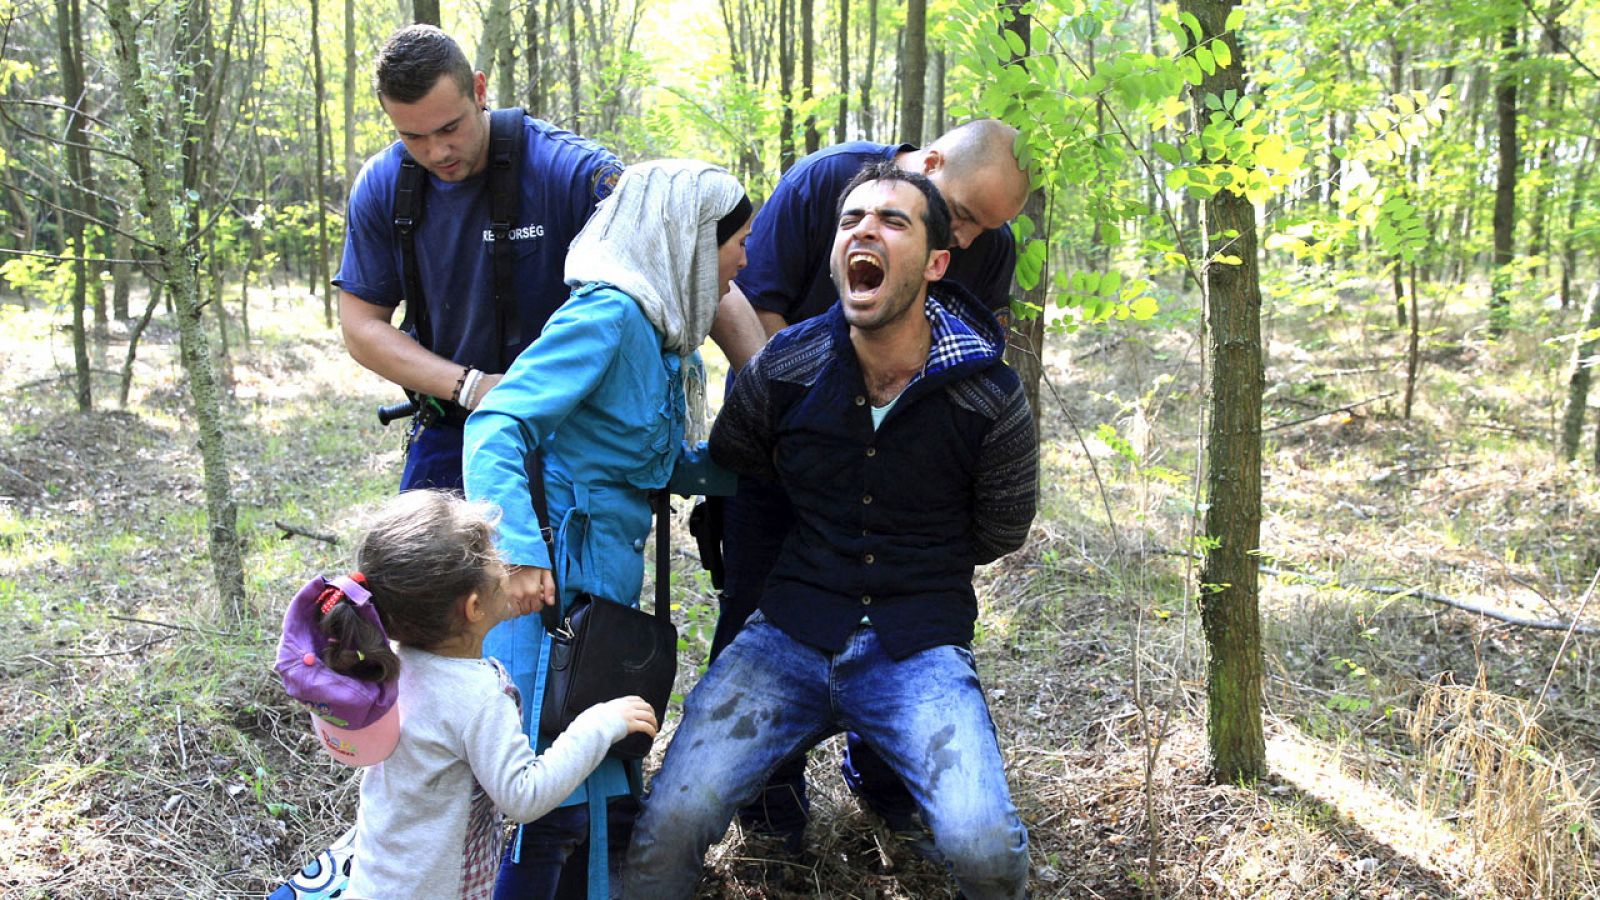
[344,647,627,900]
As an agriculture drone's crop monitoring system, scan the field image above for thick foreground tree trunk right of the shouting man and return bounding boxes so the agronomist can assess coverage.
[1178,0,1266,783]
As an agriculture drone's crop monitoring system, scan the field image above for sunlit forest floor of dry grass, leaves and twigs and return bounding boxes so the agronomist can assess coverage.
[0,275,1600,898]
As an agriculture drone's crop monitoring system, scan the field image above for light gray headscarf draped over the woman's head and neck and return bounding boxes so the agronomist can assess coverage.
[566,160,744,356]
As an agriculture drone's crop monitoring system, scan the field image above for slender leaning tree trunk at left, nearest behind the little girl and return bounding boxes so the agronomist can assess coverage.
[106,0,245,618]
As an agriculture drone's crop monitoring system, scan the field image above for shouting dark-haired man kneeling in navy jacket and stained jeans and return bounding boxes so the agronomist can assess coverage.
[624,163,1038,898]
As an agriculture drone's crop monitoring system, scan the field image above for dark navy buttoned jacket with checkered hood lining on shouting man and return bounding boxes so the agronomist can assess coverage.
[710,282,1038,658]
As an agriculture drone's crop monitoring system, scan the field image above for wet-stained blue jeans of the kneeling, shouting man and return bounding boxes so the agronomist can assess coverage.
[622,613,1027,900]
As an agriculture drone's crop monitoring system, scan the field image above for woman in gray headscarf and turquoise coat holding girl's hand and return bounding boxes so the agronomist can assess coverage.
[464,160,750,898]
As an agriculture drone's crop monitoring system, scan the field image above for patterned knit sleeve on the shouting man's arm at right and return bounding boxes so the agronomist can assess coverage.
[973,376,1038,564]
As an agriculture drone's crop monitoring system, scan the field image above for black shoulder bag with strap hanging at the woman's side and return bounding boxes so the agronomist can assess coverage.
[522,424,678,759]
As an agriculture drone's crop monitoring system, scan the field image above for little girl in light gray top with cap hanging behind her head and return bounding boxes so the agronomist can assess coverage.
[278,490,656,900]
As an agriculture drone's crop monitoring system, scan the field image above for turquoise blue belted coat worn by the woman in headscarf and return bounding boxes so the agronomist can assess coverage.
[462,285,699,806]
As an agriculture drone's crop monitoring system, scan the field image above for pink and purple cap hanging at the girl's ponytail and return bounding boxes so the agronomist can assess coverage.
[275,575,400,765]
